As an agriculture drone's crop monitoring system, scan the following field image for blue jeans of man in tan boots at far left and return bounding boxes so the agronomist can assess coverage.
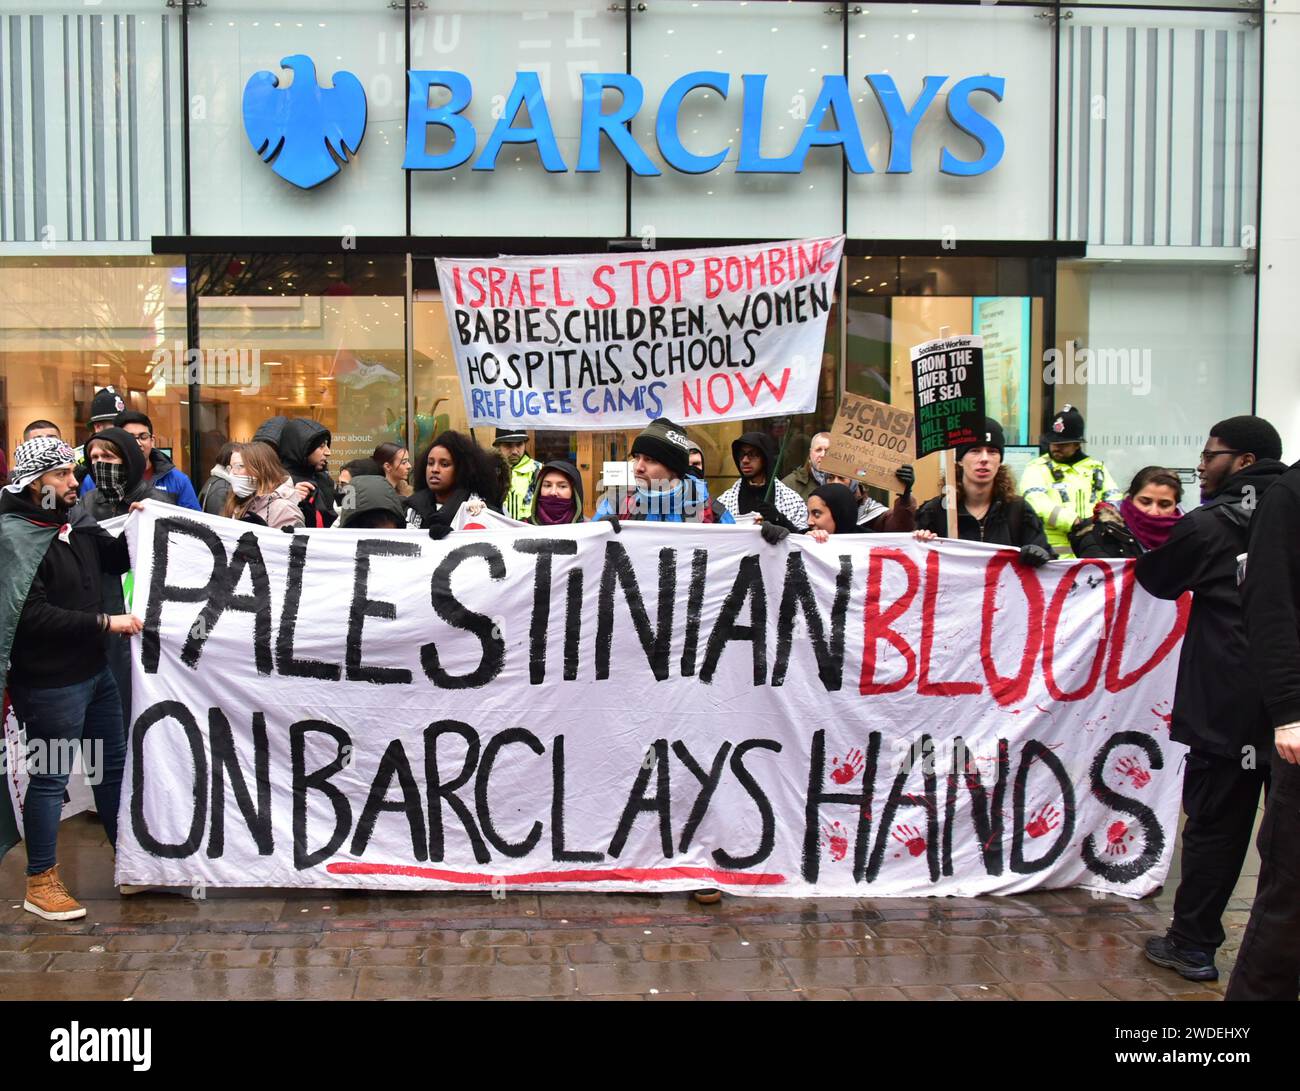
[9,667,126,875]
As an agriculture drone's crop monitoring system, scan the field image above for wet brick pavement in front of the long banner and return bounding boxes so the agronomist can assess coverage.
[0,815,1258,1000]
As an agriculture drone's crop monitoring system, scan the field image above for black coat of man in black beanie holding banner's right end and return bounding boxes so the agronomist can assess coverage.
[1134,459,1286,762]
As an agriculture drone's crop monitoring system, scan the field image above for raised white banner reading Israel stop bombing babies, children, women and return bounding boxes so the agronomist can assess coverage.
[437,235,844,429]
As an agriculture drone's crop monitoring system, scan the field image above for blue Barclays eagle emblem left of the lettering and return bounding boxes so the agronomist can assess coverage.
[243,53,365,190]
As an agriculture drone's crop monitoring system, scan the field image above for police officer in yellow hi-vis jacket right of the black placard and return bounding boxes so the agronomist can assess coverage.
[1021,404,1122,557]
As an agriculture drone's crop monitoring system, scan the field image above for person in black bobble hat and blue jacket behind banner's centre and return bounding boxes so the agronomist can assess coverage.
[595,417,738,525]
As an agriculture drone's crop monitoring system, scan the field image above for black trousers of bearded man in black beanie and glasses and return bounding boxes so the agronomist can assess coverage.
[1169,750,1270,956]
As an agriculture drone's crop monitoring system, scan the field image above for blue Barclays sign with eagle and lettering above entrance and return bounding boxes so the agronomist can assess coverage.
[244,55,1006,189]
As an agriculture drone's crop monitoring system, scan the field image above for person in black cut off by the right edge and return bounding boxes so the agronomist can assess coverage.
[1225,452,1300,1000]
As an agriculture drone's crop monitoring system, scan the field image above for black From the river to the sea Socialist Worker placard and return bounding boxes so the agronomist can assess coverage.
[911,334,985,458]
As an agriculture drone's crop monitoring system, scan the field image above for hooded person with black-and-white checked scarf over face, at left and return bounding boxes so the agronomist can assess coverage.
[81,428,176,723]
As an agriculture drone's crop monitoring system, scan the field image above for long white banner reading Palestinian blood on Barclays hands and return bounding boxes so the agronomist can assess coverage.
[117,505,1188,896]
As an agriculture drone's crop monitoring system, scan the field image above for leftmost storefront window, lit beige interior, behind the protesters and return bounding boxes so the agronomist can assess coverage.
[0,257,190,469]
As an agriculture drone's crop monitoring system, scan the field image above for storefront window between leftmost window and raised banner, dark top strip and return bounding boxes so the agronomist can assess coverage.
[190,255,407,488]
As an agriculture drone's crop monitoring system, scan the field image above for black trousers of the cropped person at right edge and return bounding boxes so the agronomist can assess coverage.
[1225,753,1300,1000]
